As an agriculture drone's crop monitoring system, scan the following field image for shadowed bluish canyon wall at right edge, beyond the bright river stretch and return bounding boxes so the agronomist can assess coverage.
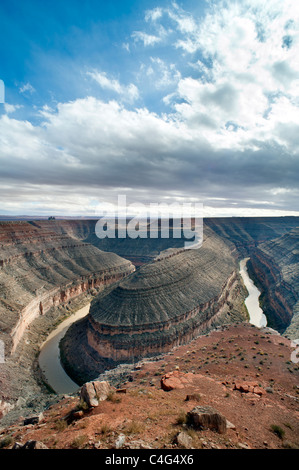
[249,228,299,339]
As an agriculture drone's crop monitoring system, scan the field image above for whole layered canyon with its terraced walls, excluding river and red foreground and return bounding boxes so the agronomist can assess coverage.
[0,217,299,428]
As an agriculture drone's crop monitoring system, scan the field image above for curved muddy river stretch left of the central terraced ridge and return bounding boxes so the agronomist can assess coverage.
[38,304,90,393]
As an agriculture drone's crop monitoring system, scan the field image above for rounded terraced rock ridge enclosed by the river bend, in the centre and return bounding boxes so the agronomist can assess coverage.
[61,228,247,383]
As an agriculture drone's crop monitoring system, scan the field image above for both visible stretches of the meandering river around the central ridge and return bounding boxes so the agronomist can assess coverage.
[39,258,267,393]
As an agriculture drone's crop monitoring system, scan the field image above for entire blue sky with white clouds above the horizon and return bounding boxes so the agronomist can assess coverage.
[0,0,299,216]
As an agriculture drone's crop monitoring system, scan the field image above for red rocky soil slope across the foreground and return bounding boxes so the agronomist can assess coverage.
[0,324,299,449]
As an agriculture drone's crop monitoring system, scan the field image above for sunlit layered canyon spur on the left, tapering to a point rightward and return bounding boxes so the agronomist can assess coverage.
[0,222,134,354]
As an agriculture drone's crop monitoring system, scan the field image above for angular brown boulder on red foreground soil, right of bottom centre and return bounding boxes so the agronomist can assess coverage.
[187,406,227,434]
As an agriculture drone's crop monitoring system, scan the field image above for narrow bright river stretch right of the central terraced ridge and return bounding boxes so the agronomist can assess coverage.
[240,258,267,328]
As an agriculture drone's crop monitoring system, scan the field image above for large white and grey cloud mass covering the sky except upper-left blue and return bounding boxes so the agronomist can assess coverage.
[0,0,299,215]
